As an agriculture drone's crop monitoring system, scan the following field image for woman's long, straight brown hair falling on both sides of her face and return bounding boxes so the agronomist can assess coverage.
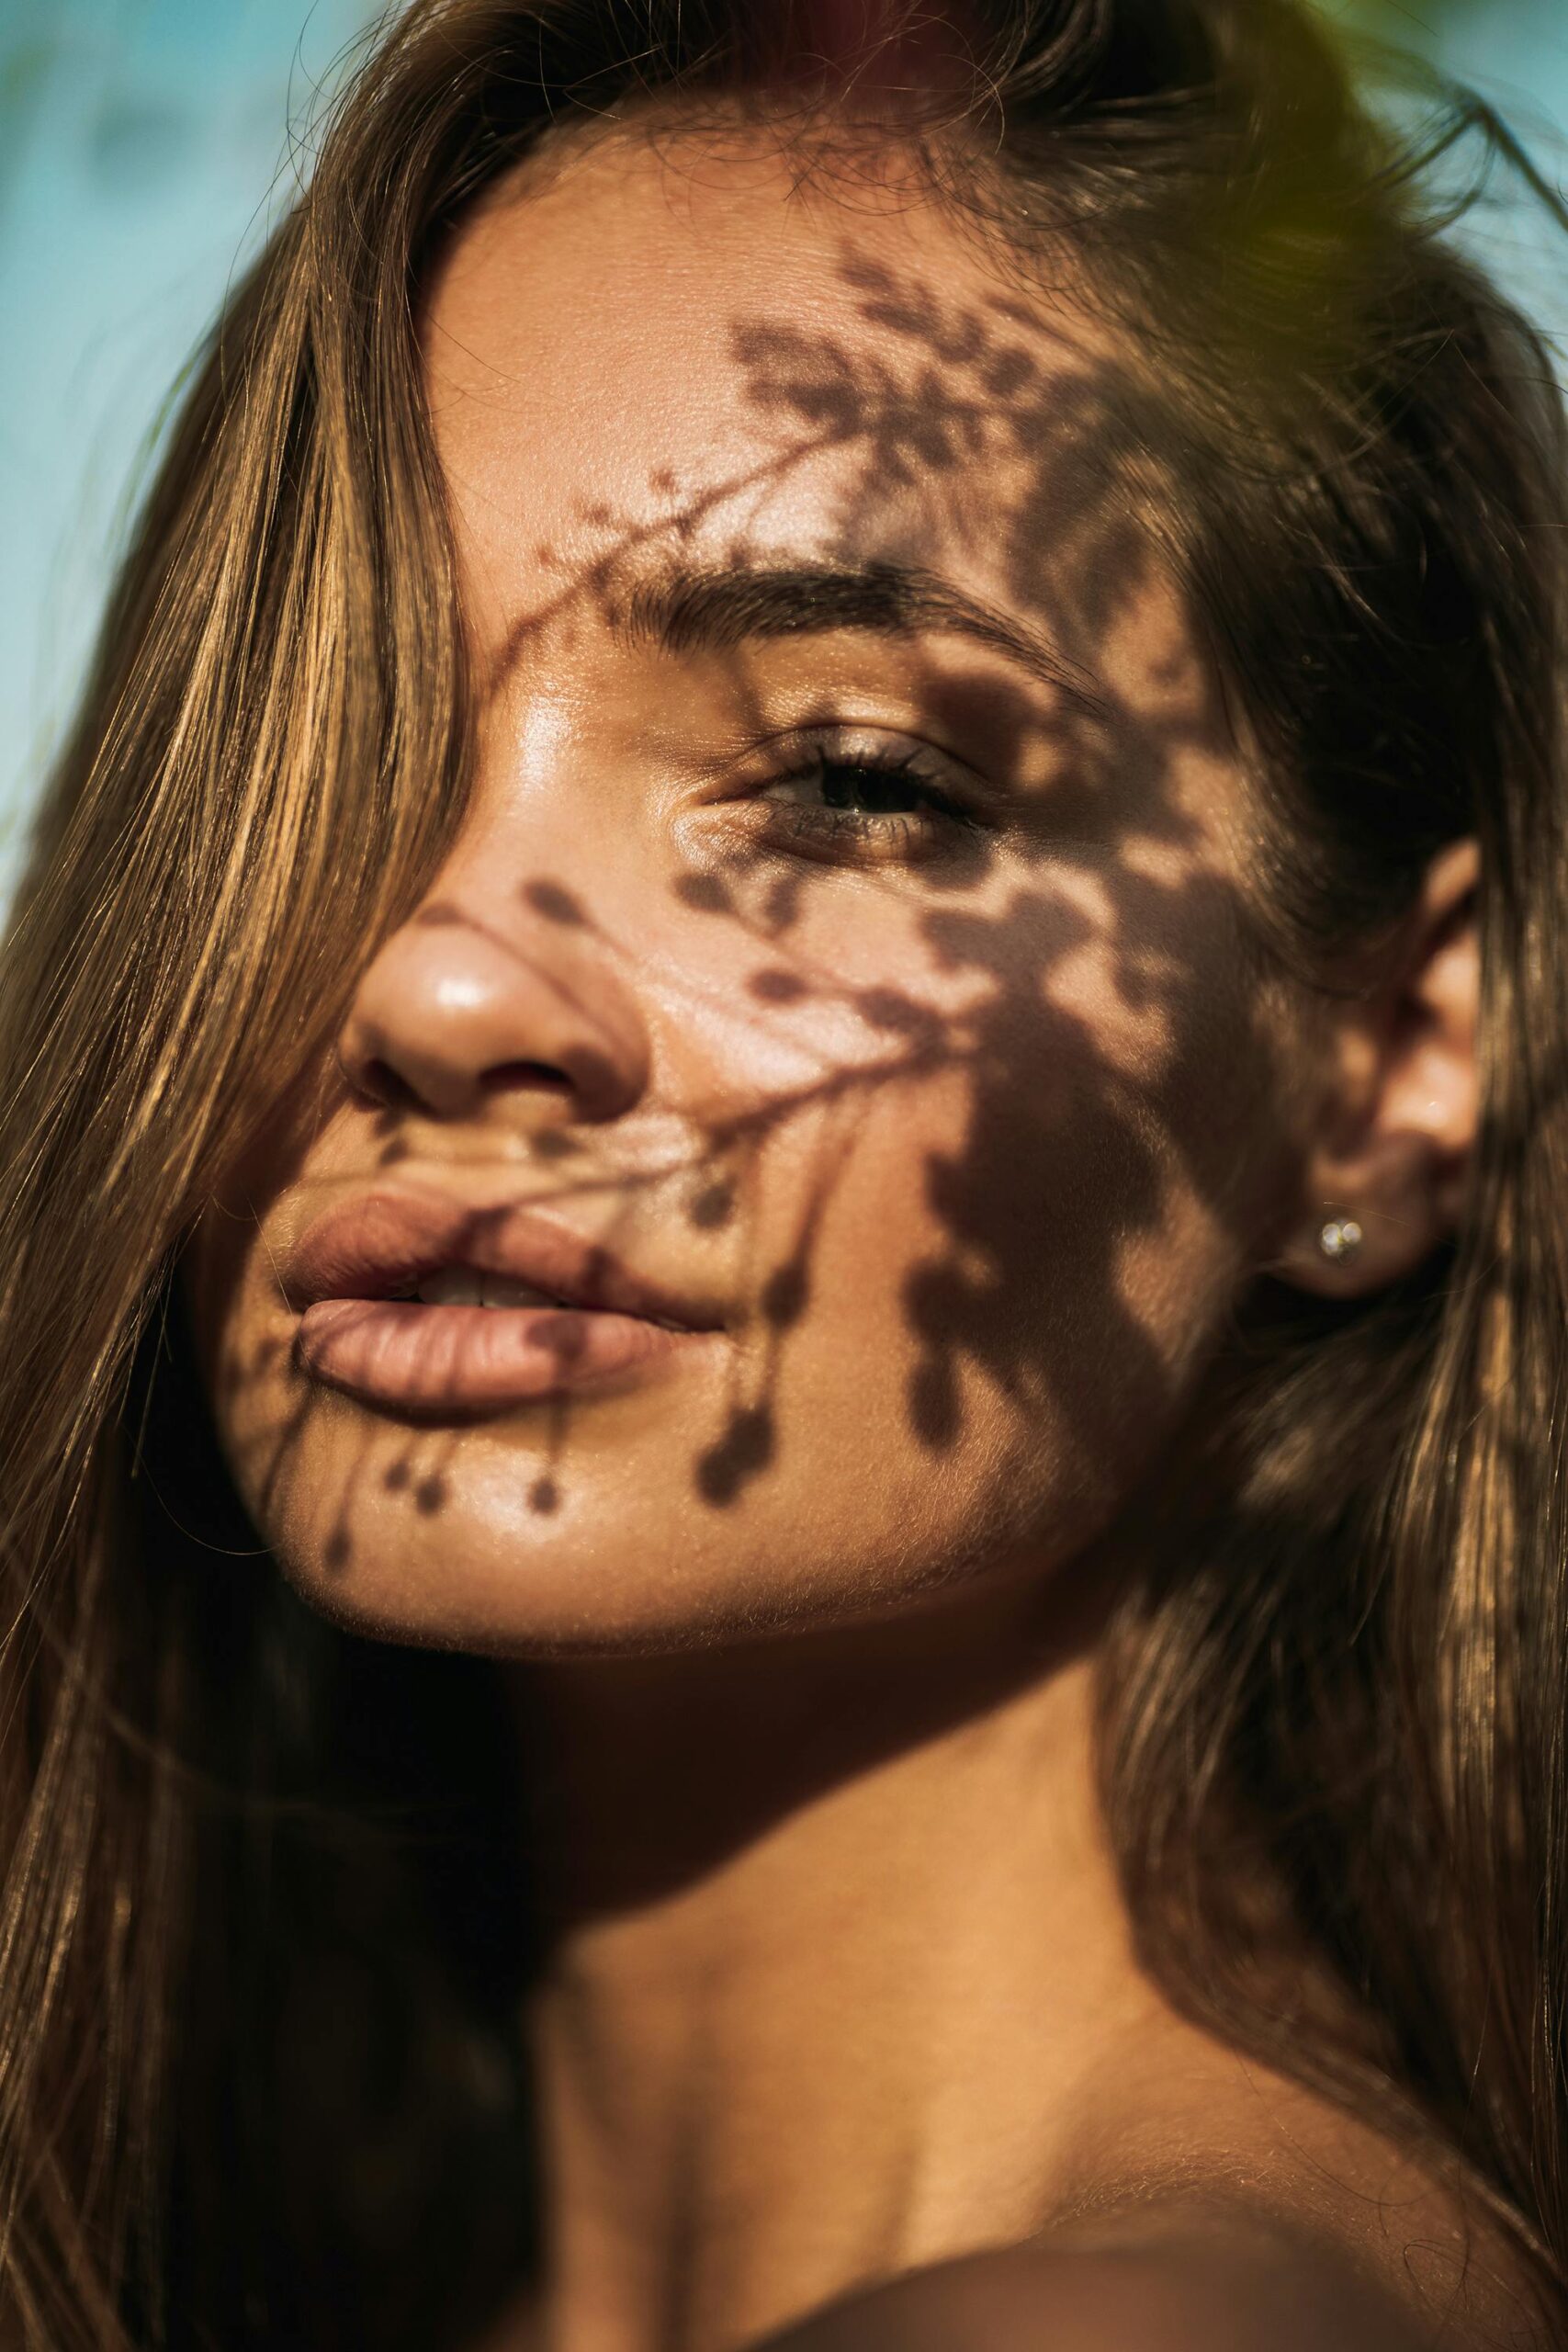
[0,0,1568,2352]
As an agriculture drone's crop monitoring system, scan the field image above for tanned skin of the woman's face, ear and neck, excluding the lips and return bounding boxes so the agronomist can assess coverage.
[188,124,1474,2352]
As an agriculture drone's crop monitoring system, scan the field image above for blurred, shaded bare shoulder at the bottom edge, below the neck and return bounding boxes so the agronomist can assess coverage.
[755,2221,1460,2352]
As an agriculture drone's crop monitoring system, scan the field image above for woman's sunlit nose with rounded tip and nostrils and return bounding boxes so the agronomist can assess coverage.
[339,894,649,1120]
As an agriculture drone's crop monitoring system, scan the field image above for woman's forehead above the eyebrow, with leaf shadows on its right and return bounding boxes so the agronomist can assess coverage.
[415,139,1166,668]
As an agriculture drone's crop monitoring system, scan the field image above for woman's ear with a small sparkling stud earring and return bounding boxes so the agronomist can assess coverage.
[1269,840,1481,1298]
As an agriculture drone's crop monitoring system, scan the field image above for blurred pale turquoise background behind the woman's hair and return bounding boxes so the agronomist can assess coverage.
[0,0,1568,908]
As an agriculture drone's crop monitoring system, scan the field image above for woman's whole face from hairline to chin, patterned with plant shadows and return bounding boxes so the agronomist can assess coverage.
[188,139,1298,1654]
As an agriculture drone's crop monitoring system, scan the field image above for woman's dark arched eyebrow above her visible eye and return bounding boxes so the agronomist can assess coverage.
[611,562,1110,719]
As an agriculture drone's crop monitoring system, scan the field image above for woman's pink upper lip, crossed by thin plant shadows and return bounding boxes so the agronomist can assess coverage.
[280,1188,722,1331]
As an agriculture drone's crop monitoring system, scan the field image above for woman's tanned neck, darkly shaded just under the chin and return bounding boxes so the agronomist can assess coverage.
[510,1588,1250,2352]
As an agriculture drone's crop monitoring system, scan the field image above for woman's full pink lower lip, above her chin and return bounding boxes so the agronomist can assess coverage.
[296,1298,717,1414]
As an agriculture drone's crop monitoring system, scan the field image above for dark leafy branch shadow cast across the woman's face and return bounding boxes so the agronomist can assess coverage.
[236,252,1269,1566]
